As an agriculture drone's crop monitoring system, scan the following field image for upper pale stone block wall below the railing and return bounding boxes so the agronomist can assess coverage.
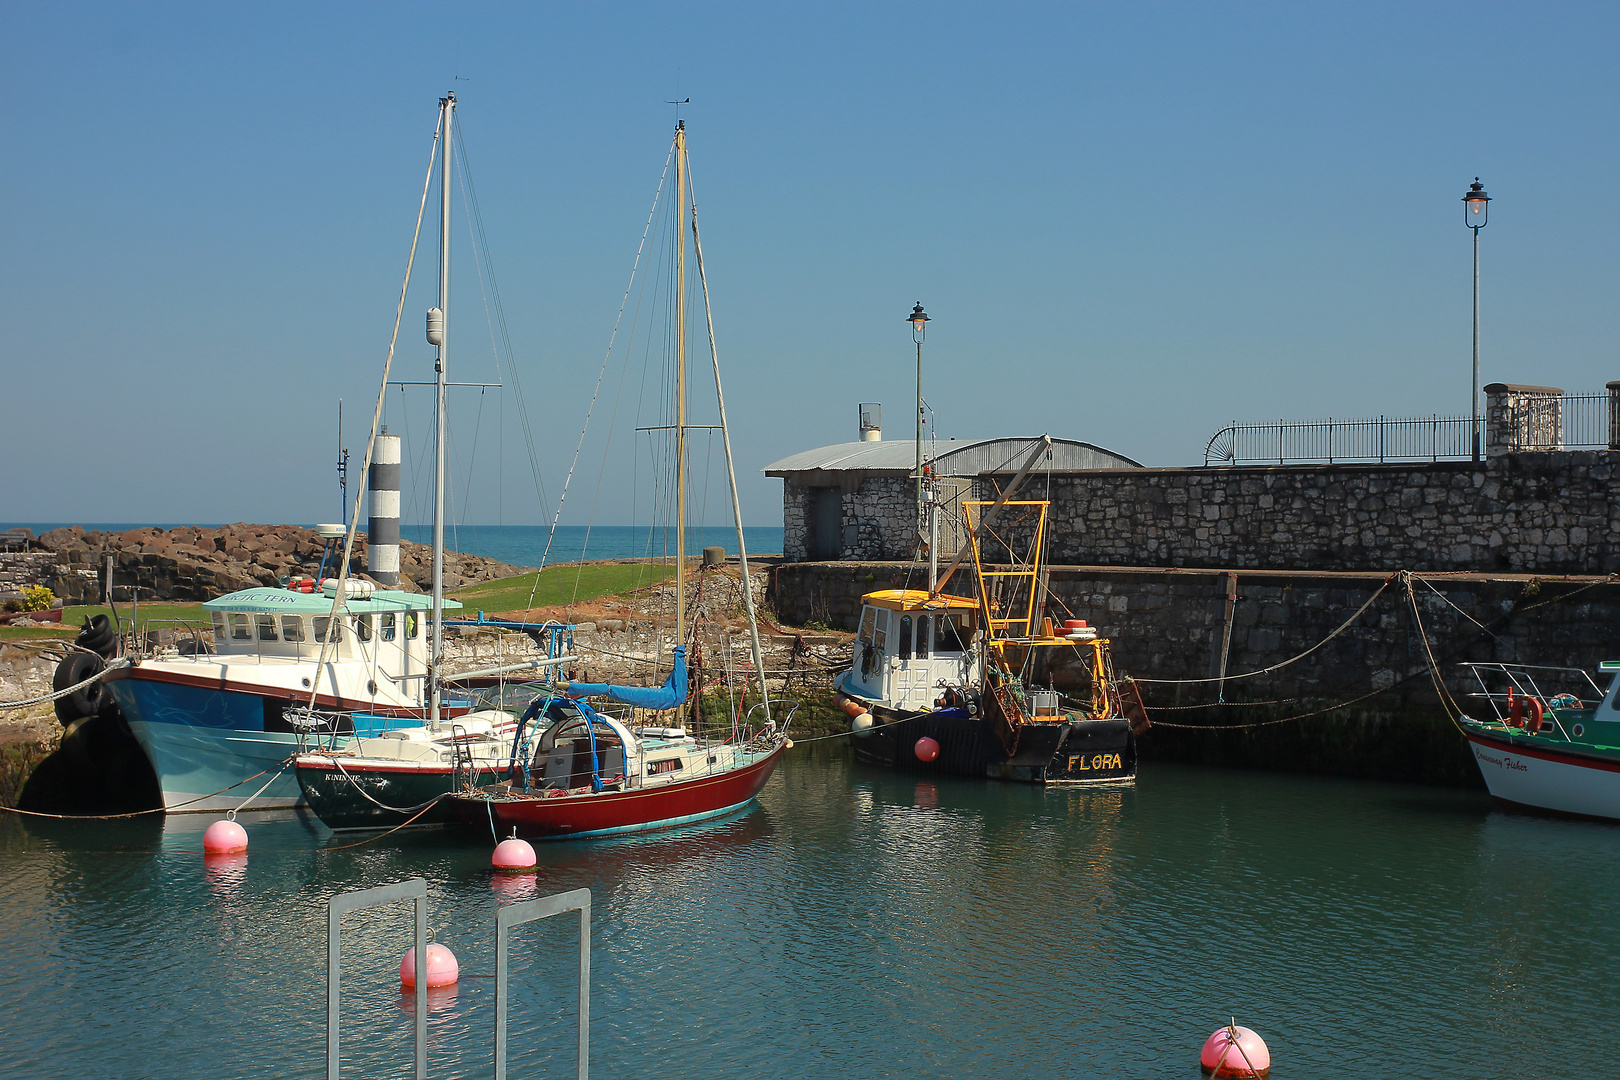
[984,450,1620,573]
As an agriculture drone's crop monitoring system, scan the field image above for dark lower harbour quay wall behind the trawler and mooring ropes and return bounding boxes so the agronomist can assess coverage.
[771,562,1620,785]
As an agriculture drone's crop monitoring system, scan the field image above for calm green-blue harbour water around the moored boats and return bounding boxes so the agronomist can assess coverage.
[0,750,1620,1080]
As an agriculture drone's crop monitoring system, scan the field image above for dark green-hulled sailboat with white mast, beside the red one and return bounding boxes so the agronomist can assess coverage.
[293,94,577,829]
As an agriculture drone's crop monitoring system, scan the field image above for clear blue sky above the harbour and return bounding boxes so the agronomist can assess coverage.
[0,0,1620,525]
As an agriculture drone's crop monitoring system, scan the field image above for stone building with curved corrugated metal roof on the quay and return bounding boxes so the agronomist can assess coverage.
[763,436,1142,562]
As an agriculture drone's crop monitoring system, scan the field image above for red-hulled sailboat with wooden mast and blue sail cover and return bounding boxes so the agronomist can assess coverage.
[449,121,792,837]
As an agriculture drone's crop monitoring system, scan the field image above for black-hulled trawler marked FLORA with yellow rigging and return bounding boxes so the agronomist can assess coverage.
[838,466,1147,784]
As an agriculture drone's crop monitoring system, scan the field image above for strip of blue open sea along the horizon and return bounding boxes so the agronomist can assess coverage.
[0,521,782,567]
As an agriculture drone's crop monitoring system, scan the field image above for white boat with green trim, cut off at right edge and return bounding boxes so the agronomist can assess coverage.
[1456,661,1620,821]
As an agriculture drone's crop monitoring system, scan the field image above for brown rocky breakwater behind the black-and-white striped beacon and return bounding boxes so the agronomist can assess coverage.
[36,523,523,604]
